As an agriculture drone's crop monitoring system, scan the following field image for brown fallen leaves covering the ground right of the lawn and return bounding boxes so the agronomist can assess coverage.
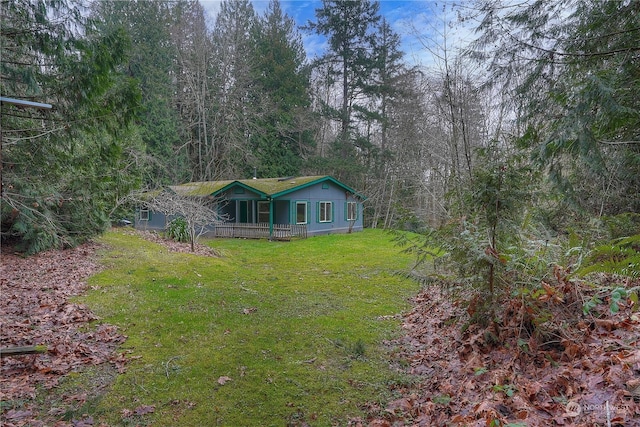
[360,274,640,427]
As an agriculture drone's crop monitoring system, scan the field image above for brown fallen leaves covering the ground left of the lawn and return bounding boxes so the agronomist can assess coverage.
[0,243,129,427]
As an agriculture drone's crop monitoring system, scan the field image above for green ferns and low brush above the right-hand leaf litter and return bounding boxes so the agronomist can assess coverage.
[396,211,640,354]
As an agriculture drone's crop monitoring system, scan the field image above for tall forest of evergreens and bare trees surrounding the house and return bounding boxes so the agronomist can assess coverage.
[0,0,640,261]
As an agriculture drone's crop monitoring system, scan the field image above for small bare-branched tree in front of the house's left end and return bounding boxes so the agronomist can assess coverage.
[144,190,223,252]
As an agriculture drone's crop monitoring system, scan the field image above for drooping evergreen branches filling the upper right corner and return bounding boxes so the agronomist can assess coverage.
[476,0,640,214]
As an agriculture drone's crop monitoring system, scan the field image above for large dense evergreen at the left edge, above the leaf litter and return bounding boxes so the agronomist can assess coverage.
[0,0,139,252]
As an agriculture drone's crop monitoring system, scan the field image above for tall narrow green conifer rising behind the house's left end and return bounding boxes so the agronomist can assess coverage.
[94,0,188,187]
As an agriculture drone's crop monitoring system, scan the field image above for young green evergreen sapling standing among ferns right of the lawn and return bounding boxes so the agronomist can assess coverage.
[400,150,548,335]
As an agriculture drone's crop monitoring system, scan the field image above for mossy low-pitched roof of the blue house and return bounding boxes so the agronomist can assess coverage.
[170,175,366,200]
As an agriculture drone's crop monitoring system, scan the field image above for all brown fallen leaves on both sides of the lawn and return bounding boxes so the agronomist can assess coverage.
[0,235,640,427]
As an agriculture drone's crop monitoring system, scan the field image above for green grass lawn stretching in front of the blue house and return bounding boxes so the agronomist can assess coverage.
[76,230,418,426]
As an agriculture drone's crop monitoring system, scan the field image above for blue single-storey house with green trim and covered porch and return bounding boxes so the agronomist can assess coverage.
[136,175,366,239]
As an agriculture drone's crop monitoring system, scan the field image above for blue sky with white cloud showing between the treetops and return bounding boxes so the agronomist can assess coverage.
[200,0,472,67]
